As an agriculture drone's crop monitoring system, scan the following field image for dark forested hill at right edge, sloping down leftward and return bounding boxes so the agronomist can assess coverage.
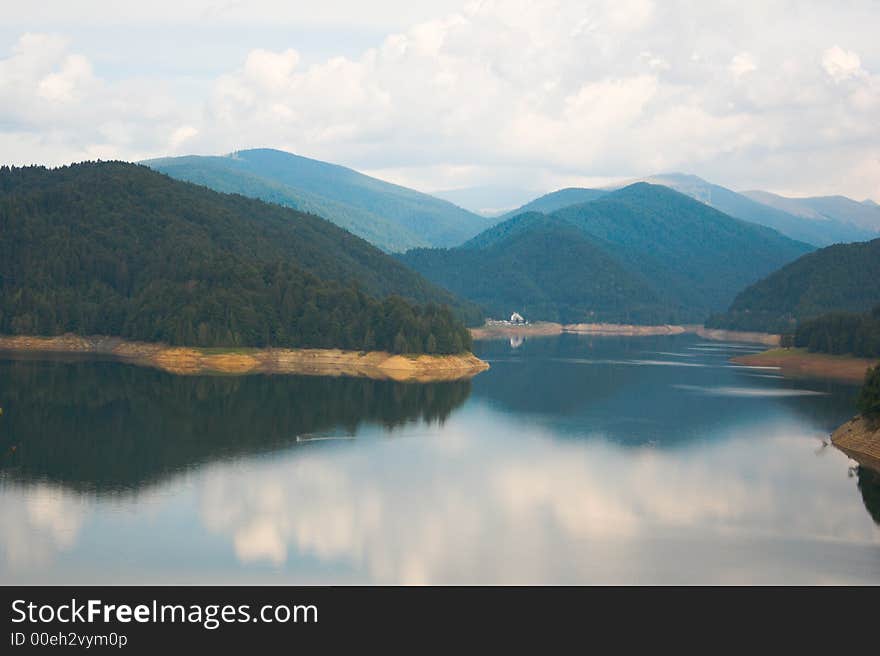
[708,239,880,333]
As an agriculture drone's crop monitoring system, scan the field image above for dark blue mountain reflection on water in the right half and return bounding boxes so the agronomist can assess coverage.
[474,335,855,444]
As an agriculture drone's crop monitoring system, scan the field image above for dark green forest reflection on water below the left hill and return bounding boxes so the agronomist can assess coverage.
[0,361,471,492]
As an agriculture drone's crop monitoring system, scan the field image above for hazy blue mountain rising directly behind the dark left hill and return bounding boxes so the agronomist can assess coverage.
[144,149,495,251]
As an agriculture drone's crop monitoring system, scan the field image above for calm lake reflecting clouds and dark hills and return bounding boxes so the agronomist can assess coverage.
[0,335,880,584]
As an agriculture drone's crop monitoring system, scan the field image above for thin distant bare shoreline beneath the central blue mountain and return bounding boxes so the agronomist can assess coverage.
[470,321,780,346]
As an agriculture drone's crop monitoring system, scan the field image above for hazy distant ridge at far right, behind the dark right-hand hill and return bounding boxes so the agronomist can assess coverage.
[624,173,875,246]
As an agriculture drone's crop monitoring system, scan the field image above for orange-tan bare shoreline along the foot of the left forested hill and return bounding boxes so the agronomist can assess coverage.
[0,334,489,382]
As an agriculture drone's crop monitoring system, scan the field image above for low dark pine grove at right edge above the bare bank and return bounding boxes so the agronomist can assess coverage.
[794,305,880,358]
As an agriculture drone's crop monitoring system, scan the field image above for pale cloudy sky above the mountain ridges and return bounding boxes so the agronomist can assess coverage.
[0,0,880,202]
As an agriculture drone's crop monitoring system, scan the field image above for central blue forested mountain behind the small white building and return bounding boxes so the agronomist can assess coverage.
[399,183,811,323]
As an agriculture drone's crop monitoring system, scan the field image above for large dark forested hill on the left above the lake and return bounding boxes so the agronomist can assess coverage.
[0,162,479,352]
